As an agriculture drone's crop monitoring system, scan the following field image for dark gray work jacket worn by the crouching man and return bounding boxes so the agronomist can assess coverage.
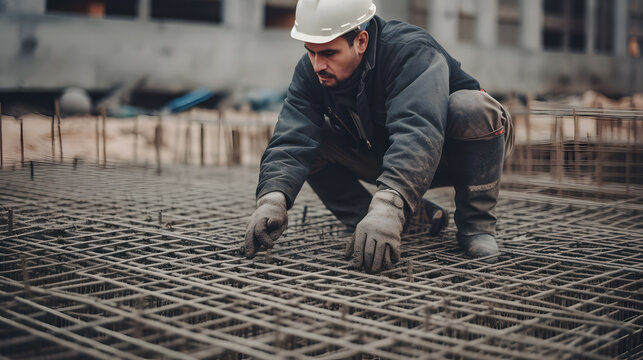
[257,16,480,211]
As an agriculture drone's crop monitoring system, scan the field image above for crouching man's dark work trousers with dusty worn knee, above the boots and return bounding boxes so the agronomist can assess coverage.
[307,90,514,227]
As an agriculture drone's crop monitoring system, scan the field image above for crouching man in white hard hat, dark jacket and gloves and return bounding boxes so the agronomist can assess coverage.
[244,0,513,273]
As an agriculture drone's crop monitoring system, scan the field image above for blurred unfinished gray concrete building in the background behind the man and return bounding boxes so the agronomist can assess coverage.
[0,0,643,95]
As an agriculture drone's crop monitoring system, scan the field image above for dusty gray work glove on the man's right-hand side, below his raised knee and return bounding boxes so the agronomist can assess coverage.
[346,190,404,273]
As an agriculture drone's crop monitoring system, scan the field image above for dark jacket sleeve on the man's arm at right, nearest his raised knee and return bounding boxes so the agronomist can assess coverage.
[377,43,449,212]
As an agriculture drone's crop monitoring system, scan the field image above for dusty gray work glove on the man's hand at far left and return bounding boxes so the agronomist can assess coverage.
[243,191,288,259]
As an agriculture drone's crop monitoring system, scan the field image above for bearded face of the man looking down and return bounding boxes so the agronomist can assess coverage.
[304,31,368,87]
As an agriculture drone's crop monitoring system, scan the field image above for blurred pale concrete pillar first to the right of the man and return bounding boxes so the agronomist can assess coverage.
[427,0,458,45]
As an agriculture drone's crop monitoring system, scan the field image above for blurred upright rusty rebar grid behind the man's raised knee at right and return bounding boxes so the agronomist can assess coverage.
[505,107,643,187]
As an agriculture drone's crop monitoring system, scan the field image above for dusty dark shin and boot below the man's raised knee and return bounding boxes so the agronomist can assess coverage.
[446,134,505,263]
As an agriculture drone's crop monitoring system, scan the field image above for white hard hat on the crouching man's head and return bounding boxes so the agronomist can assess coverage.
[290,0,375,44]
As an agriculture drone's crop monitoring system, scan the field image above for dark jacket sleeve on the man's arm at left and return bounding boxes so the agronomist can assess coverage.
[256,56,324,208]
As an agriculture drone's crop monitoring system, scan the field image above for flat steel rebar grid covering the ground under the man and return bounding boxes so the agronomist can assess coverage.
[0,163,643,359]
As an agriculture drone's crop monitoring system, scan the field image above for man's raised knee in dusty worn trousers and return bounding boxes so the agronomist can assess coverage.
[446,90,507,140]
